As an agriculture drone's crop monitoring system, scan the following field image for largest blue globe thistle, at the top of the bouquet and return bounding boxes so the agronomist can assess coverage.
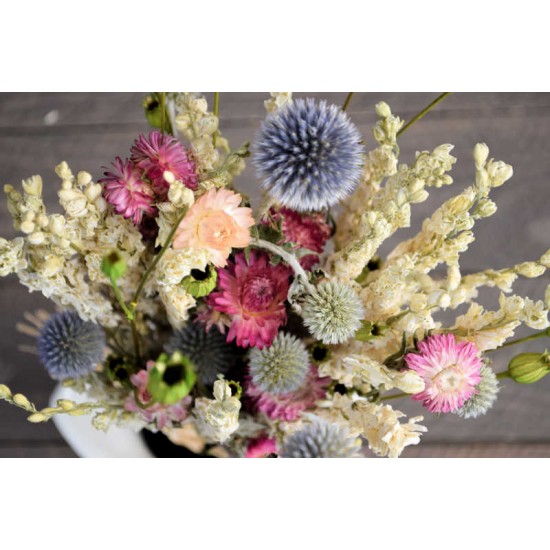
[253,98,363,212]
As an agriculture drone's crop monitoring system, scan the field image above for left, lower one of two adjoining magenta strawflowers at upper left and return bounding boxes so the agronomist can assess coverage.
[99,157,157,225]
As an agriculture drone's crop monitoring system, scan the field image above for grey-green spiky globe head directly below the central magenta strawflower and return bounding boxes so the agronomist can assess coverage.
[249,332,309,395]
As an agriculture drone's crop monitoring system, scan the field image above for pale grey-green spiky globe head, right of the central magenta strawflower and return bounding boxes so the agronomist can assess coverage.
[302,280,365,344]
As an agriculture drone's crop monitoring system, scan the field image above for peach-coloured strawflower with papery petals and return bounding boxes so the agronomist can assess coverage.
[173,189,254,267]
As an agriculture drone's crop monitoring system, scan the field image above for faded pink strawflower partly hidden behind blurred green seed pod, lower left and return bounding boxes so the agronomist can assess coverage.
[124,361,192,430]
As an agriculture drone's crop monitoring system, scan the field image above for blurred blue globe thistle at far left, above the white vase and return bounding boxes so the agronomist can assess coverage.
[37,311,105,380]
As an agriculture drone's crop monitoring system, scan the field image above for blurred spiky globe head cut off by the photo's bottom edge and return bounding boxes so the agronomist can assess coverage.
[281,418,361,458]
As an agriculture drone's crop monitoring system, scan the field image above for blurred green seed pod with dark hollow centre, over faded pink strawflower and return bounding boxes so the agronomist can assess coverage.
[147,352,196,405]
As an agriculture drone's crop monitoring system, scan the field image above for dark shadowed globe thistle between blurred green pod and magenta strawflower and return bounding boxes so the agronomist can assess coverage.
[165,323,236,386]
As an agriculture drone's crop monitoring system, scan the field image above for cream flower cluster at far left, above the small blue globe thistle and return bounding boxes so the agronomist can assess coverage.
[0,162,145,326]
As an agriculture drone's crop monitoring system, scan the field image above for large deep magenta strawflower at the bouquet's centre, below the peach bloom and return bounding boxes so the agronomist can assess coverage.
[208,250,291,349]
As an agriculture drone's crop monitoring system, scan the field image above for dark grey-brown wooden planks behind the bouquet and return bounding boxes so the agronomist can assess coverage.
[0,92,550,457]
